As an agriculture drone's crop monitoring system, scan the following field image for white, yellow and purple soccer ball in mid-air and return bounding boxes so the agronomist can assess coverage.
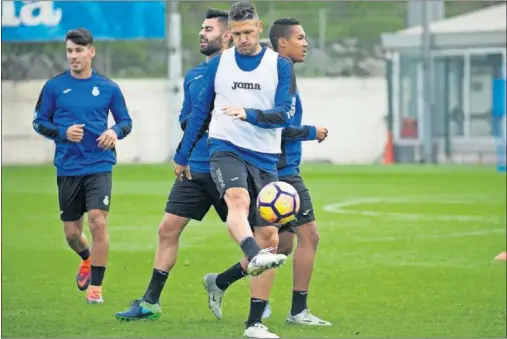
[257,181,299,225]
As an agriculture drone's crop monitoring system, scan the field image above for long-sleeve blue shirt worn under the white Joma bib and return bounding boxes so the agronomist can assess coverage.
[174,48,297,173]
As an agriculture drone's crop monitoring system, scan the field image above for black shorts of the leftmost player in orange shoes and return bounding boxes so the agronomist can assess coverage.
[56,172,113,221]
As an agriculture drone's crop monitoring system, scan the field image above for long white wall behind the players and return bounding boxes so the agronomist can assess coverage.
[2,78,387,165]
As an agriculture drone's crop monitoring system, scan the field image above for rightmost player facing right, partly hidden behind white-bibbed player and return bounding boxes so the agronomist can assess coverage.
[202,18,331,326]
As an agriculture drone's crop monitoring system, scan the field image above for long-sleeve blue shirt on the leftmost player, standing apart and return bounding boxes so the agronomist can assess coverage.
[33,71,132,176]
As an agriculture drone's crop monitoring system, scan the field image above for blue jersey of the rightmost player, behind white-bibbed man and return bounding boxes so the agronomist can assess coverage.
[278,93,317,177]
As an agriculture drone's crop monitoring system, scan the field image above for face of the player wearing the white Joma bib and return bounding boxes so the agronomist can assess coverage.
[230,19,262,55]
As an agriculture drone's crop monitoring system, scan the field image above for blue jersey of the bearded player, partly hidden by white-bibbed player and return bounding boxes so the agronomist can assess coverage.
[179,62,210,173]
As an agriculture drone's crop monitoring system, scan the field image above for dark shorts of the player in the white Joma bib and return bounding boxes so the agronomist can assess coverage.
[211,151,278,227]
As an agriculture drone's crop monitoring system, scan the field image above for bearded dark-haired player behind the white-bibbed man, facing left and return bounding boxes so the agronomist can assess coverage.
[116,8,231,320]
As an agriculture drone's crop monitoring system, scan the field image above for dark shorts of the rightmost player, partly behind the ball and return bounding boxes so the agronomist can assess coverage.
[280,175,315,232]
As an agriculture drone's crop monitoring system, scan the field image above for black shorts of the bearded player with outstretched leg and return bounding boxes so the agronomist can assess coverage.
[165,172,227,222]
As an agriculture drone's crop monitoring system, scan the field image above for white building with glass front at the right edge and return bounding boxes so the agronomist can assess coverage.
[382,3,507,162]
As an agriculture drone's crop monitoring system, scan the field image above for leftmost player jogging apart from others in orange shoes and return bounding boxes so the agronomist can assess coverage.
[33,28,132,304]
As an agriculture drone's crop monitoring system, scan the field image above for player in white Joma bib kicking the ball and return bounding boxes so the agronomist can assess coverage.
[174,2,296,338]
